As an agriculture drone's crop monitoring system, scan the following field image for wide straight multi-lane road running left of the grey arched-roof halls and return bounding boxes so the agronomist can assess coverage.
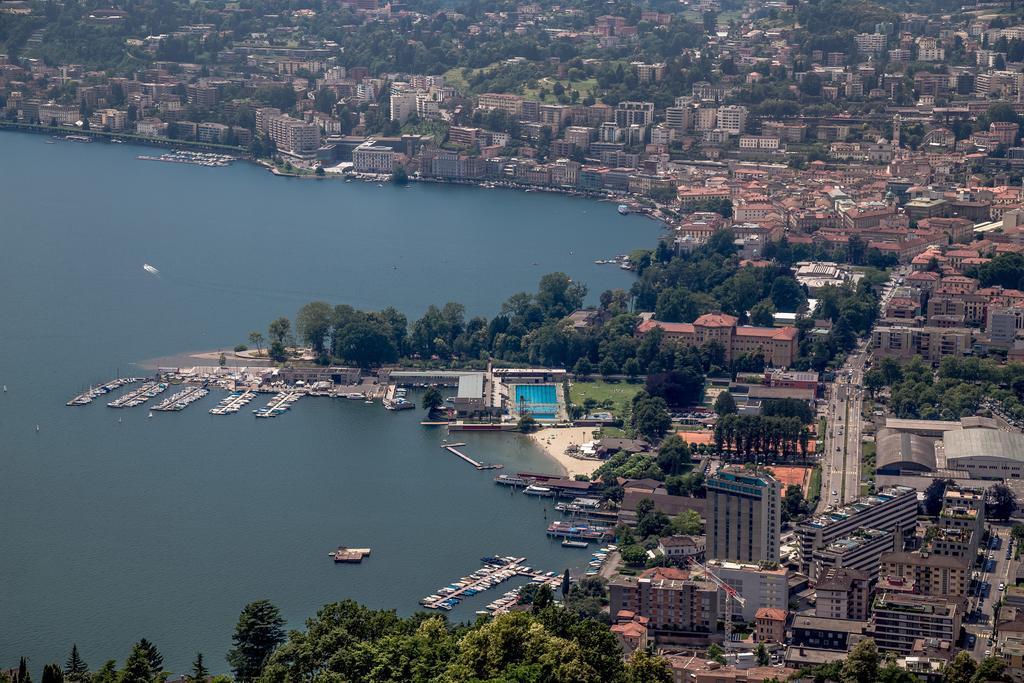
[817,272,900,513]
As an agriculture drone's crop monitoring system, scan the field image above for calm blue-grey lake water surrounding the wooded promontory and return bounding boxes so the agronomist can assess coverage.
[0,133,658,676]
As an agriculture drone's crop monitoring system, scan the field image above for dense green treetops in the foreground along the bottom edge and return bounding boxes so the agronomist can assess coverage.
[8,598,672,683]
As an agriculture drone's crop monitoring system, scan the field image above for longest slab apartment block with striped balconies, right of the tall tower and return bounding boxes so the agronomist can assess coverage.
[795,486,918,573]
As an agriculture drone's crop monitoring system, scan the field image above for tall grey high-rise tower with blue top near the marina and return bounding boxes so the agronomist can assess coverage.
[705,466,782,562]
